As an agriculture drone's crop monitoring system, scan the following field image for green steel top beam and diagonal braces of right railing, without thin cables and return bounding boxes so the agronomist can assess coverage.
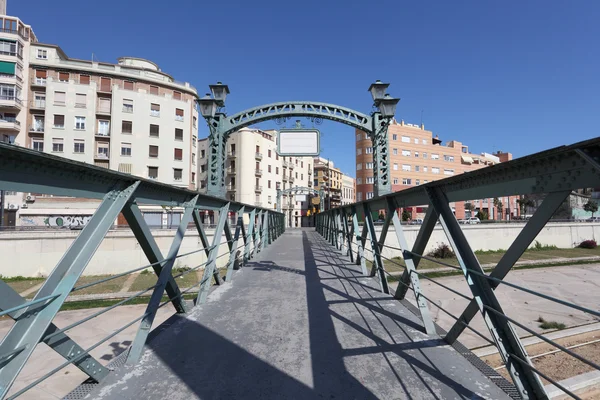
[316,138,600,399]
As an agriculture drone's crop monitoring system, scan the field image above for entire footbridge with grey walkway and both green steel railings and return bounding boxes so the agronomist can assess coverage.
[0,139,600,399]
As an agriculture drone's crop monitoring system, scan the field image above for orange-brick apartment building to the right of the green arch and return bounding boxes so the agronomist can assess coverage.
[356,121,519,219]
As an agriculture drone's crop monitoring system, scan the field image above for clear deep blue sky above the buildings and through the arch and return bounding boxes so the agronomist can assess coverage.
[8,0,600,175]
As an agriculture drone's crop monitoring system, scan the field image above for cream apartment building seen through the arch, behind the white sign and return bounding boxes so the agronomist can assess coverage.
[198,128,313,226]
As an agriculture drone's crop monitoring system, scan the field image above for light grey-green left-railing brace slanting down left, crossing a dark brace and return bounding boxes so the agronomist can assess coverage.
[127,199,196,364]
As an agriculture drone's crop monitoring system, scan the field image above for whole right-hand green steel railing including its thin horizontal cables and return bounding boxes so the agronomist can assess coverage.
[316,139,600,399]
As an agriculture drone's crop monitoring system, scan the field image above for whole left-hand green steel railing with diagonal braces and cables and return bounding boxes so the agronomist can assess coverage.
[0,143,285,399]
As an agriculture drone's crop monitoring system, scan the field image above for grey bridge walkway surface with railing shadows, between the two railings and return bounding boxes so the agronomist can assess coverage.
[86,229,508,399]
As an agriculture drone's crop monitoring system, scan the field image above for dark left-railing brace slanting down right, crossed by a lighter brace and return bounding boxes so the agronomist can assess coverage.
[122,203,186,313]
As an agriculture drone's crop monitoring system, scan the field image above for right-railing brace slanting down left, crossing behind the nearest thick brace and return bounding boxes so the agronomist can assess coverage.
[444,190,571,344]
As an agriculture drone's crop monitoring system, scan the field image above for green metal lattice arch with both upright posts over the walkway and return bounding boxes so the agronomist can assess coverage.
[207,101,393,198]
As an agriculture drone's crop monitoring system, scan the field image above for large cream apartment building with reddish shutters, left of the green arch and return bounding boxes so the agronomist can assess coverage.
[0,5,198,225]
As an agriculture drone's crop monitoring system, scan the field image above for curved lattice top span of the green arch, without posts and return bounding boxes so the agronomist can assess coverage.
[222,101,372,136]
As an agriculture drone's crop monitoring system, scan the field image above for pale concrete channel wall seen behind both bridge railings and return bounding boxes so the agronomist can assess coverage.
[0,223,600,277]
